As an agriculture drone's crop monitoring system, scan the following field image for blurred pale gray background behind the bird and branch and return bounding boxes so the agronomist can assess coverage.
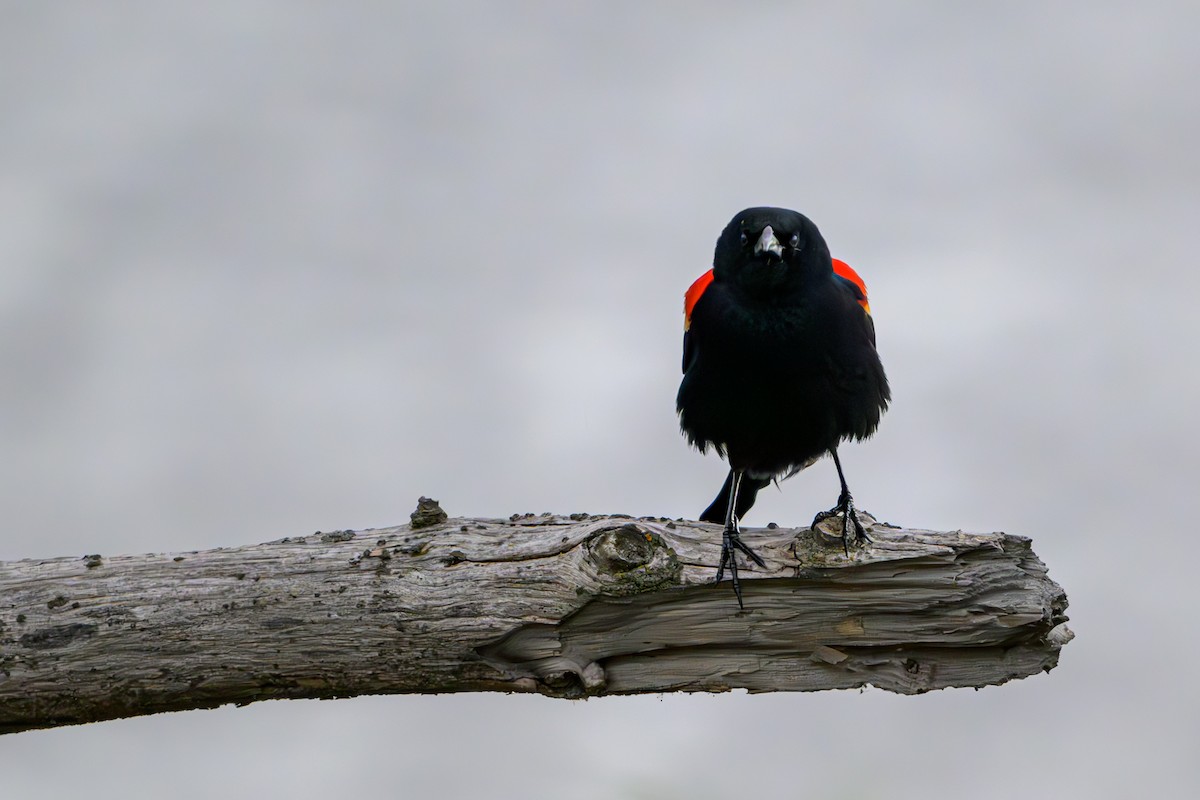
[0,0,1200,800]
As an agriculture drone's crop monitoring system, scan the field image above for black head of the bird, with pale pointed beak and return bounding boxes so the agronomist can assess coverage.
[713,207,832,295]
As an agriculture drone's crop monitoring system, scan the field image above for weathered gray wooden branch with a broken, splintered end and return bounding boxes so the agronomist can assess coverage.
[0,499,1072,733]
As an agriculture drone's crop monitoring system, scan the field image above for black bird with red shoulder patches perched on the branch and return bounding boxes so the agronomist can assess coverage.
[676,207,892,606]
